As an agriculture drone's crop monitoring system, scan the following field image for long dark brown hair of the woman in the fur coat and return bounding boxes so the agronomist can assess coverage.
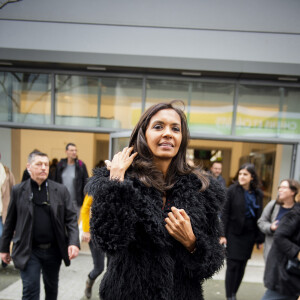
[128,100,209,193]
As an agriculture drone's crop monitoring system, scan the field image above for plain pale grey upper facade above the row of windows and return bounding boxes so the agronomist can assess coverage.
[0,0,300,75]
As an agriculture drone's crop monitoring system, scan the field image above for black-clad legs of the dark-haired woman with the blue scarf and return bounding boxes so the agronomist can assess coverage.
[225,259,248,298]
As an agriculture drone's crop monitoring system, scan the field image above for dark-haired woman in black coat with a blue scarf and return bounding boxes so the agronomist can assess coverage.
[221,163,264,300]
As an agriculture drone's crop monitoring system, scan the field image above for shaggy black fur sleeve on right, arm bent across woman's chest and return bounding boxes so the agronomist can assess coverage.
[176,180,225,281]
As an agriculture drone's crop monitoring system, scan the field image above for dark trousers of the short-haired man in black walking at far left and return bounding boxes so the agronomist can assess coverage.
[21,247,62,300]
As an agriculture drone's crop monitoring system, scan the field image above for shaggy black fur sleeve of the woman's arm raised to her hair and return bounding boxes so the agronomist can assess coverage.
[85,168,139,254]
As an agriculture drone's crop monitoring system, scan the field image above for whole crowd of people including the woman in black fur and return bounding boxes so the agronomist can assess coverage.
[0,101,300,300]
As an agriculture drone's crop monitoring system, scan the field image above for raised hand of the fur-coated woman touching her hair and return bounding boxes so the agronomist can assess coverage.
[105,147,138,181]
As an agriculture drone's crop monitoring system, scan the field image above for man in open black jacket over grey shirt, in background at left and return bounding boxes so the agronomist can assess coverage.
[55,143,89,219]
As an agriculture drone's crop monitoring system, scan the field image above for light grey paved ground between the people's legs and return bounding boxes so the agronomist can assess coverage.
[0,245,265,300]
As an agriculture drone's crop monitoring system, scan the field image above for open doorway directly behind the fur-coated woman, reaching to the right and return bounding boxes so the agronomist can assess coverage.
[109,131,294,206]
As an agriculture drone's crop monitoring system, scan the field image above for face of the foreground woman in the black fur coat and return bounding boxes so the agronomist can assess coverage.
[145,109,182,162]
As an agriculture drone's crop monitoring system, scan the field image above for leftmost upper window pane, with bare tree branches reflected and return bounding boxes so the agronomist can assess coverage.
[0,73,51,124]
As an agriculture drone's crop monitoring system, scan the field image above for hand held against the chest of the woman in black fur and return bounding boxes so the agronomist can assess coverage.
[165,206,196,252]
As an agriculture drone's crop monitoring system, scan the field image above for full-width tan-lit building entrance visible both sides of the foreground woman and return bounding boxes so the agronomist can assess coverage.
[7,129,295,205]
